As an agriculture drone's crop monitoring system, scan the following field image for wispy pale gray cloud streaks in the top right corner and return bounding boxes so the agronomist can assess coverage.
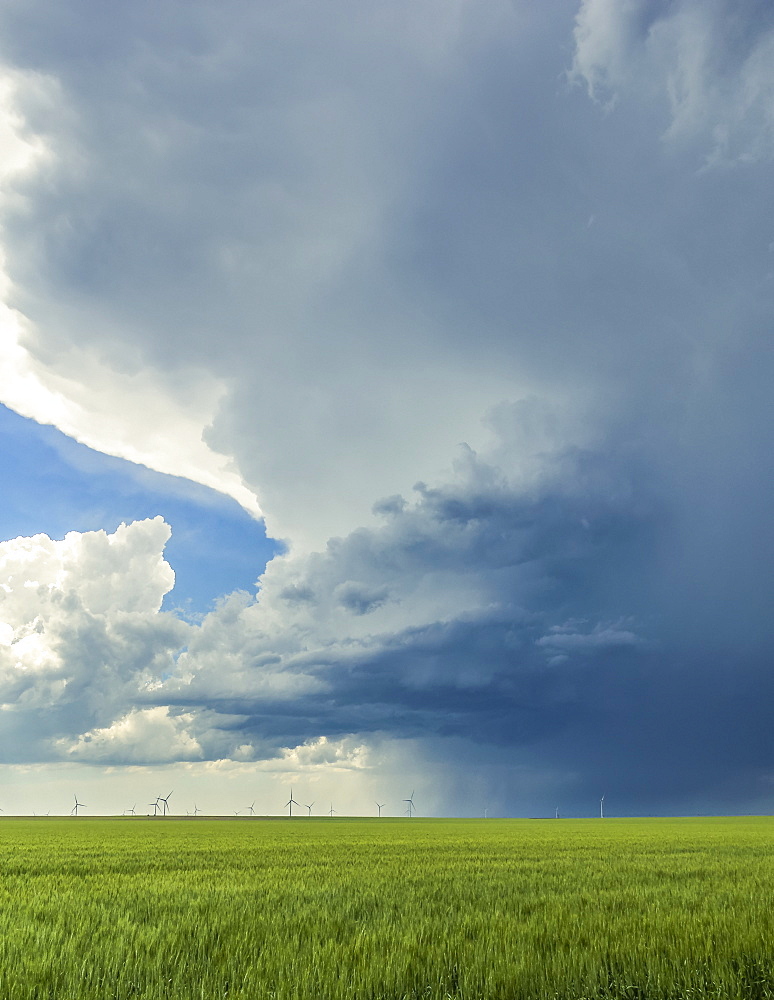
[572,0,774,165]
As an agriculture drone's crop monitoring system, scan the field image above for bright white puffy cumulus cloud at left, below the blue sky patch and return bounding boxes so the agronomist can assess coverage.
[0,517,187,758]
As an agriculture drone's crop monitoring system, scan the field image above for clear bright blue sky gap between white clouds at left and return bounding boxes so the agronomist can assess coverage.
[0,406,282,616]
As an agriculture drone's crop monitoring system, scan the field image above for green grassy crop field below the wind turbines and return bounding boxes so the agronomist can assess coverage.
[0,817,774,1000]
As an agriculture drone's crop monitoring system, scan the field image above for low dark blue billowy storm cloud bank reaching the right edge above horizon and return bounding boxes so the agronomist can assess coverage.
[155,386,773,812]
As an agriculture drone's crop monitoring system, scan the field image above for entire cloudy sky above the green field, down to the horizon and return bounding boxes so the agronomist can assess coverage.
[0,0,774,816]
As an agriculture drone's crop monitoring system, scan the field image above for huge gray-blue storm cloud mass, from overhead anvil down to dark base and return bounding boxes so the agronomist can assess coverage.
[5,0,774,812]
